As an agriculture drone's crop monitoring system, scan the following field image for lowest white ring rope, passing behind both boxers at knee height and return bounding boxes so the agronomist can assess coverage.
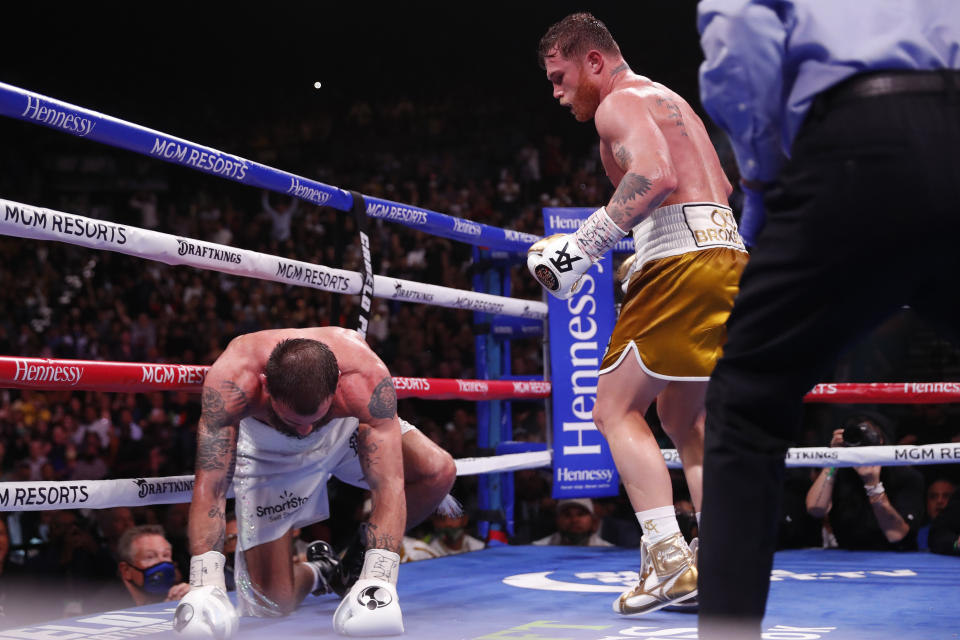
[0,442,960,511]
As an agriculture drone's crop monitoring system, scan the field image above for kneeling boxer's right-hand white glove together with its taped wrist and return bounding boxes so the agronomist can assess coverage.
[333,549,403,637]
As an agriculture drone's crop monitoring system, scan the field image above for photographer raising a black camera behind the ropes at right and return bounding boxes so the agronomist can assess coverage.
[807,417,923,551]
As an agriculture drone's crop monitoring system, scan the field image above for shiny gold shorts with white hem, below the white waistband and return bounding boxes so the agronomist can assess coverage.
[600,247,748,381]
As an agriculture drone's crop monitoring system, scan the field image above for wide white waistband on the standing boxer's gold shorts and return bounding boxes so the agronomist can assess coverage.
[633,202,746,270]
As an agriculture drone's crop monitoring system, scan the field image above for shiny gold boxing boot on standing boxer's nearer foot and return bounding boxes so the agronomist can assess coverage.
[613,533,697,616]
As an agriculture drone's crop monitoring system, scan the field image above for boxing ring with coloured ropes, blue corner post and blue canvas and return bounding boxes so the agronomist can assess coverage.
[0,83,960,640]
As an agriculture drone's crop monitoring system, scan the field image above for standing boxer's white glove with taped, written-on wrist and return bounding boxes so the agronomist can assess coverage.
[527,207,627,300]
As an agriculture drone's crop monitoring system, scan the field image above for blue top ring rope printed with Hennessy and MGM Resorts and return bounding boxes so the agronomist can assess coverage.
[0,82,556,256]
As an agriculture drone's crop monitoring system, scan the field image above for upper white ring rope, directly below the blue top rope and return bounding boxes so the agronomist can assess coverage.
[0,198,547,319]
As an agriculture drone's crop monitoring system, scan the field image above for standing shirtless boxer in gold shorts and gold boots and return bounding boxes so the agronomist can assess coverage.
[528,13,747,615]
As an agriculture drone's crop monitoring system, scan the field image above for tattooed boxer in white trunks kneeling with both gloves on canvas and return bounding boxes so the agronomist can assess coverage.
[174,327,456,637]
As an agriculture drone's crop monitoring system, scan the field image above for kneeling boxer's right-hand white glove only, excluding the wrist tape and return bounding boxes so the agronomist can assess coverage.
[333,578,403,637]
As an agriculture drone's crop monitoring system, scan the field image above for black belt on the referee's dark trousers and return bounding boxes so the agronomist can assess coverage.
[817,69,960,107]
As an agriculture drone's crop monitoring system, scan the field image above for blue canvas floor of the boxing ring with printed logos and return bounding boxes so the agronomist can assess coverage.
[0,546,960,640]
